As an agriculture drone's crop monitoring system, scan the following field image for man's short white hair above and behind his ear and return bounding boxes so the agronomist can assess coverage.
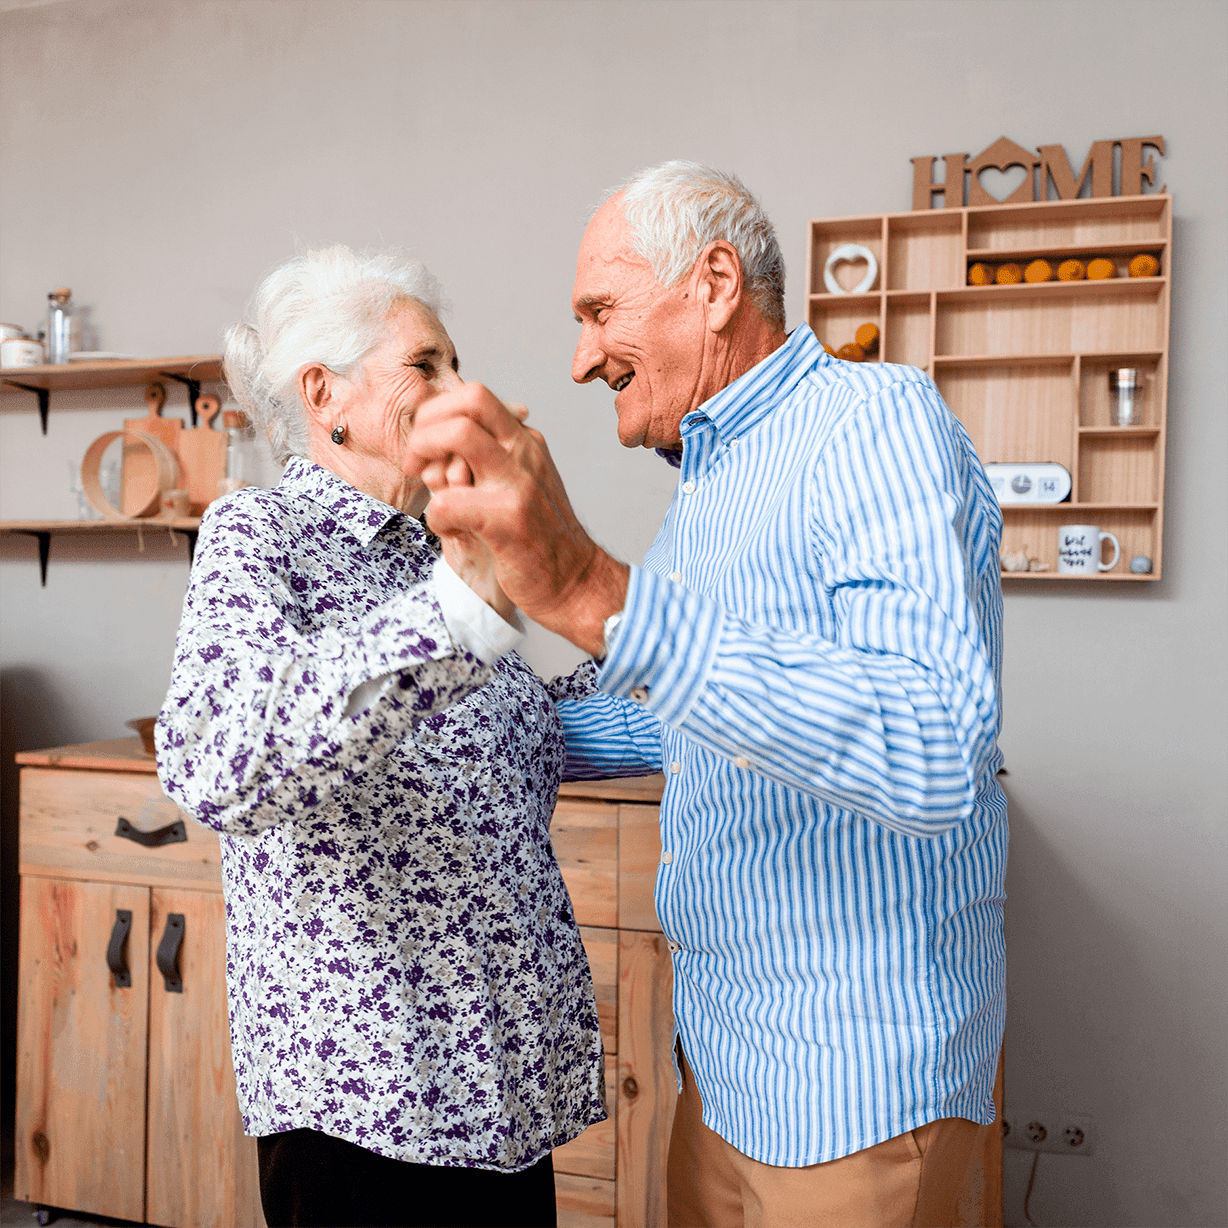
[603,162,785,329]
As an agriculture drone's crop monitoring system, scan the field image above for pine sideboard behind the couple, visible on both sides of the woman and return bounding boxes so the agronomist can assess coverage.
[14,738,675,1228]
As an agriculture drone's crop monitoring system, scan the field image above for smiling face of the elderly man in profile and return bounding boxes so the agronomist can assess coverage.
[571,193,717,448]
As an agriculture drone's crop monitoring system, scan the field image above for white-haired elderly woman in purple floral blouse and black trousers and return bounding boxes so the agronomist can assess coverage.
[157,247,604,1226]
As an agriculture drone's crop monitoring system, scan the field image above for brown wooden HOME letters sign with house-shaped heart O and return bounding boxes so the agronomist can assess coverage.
[910,136,1168,210]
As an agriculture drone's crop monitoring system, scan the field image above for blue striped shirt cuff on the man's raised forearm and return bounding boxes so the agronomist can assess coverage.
[597,566,725,728]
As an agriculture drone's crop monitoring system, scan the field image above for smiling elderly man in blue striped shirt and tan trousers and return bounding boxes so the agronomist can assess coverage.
[414,162,1007,1228]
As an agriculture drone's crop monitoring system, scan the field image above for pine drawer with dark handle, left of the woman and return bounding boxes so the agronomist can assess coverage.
[20,768,221,890]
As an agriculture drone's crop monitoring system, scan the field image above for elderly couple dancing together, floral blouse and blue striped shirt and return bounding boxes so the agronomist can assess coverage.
[157,162,1006,1228]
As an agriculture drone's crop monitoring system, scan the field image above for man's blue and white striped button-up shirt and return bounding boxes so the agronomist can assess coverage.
[560,327,1007,1167]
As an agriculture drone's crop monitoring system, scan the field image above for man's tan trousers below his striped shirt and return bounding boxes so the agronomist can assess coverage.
[667,1045,1002,1228]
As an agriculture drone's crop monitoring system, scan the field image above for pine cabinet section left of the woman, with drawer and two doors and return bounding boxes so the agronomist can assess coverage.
[14,738,264,1228]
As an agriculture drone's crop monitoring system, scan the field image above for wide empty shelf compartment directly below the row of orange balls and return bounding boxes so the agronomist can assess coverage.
[935,282,1167,358]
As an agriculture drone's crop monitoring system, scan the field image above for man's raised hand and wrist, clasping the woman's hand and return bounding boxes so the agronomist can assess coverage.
[408,383,628,656]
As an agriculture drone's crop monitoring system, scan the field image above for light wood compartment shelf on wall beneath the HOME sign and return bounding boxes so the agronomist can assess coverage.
[807,194,1173,583]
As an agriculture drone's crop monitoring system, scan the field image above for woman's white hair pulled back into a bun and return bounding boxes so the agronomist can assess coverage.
[223,244,443,464]
